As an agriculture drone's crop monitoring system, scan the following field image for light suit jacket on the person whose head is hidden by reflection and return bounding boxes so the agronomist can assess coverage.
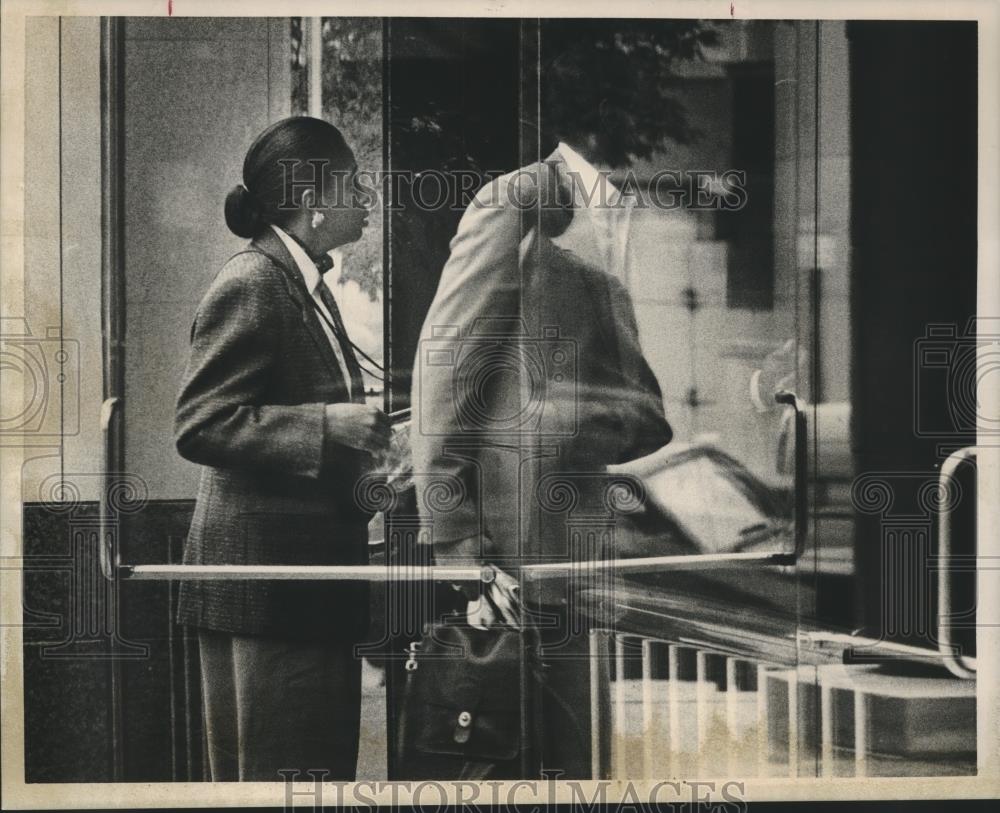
[411,152,671,566]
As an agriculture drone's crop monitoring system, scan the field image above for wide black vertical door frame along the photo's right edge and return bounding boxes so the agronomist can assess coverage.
[847,20,980,654]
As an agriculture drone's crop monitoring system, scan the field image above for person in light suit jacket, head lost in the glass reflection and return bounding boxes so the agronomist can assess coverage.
[411,47,671,777]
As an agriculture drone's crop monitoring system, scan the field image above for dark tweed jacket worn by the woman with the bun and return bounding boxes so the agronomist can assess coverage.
[175,230,371,640]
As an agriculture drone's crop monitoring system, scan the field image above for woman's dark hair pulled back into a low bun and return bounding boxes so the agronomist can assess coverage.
[226,116,351,238]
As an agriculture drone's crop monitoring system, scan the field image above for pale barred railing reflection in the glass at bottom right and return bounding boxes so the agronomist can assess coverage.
[590,629,975,779]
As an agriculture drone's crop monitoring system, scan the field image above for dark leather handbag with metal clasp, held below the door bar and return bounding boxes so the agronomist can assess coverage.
[396,623,540,780]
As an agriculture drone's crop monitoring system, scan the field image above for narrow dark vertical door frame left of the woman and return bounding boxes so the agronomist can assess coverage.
[101,17,125,782]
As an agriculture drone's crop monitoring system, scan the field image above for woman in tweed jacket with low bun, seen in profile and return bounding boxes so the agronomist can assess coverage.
[176,117,389,781]
